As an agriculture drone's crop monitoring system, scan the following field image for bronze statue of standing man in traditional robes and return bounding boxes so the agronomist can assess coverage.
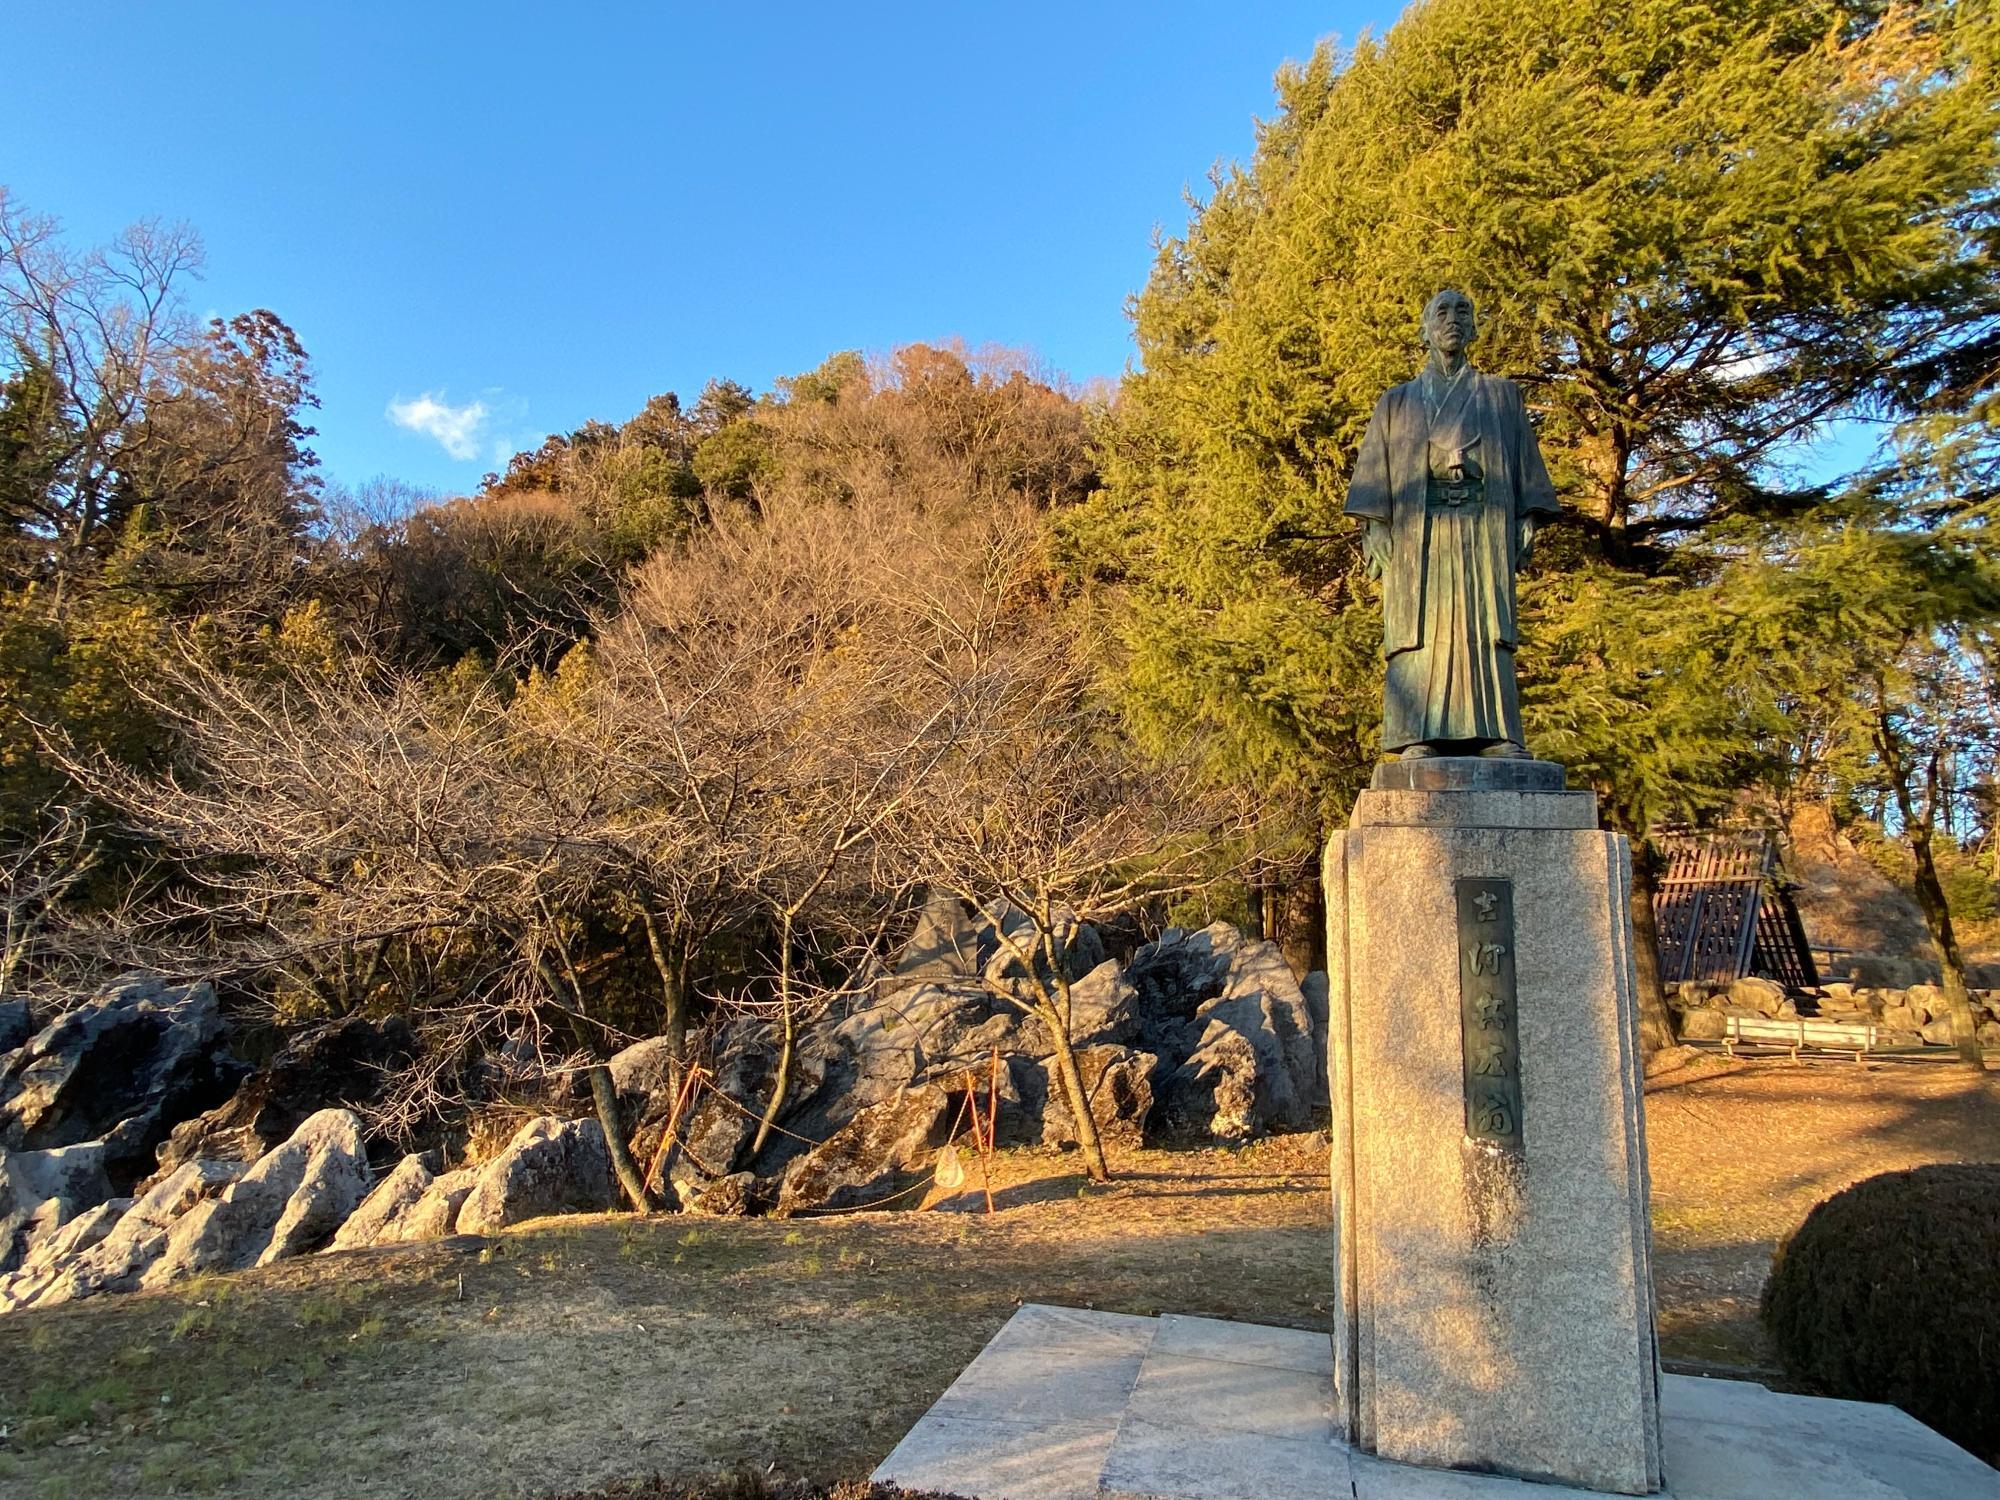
[1346,290,1558,760]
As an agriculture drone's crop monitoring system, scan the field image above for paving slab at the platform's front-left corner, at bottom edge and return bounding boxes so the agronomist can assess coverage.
[874,1406,1120,1500]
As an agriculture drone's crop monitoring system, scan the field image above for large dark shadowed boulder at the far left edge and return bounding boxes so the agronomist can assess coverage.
[0,976,244,1182]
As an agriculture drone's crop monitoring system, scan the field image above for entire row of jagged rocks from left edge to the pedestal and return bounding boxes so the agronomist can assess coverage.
[0,902,1324,1312]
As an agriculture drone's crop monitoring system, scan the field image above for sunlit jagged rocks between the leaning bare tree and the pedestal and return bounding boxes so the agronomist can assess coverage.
[660,916,1326,1212]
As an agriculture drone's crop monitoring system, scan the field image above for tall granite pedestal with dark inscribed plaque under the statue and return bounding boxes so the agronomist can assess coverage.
[1326,758,1662,1494]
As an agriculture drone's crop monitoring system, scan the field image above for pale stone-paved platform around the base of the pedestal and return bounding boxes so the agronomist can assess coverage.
[874,1304,2000,1500]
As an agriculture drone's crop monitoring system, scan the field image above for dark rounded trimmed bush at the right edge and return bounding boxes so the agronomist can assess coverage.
[1762,1164,2000,1462]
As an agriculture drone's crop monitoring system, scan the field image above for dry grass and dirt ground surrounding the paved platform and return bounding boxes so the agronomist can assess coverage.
[0,1062,2000,1500]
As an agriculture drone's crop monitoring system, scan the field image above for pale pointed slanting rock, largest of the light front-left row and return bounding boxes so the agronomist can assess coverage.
[140,1110,370,1288]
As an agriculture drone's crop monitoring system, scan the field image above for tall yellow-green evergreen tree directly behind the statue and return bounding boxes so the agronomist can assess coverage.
[1066,0,2000,1032]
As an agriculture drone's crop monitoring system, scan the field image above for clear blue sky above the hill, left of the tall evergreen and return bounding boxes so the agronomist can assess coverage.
[0,0,1400,492]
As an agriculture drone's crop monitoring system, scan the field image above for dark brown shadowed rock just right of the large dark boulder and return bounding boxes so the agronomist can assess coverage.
[142,1016,416,1186]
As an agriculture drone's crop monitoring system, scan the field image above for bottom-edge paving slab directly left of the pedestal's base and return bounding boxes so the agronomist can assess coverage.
[1098,1416,1350,1500]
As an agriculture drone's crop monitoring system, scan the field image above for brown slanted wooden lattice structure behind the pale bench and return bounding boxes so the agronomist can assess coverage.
[1652,832,1820,990]
